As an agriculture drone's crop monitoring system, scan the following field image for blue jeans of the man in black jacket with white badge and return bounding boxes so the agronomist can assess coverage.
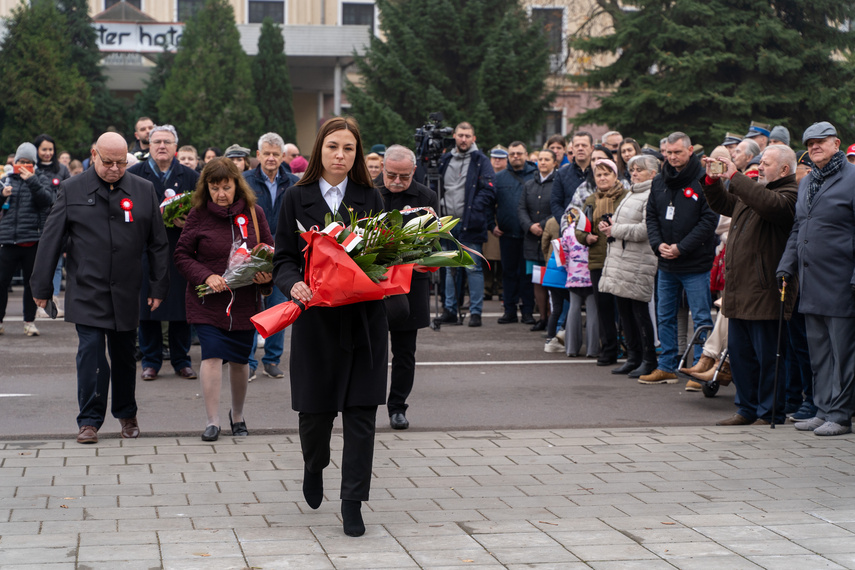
[656,269,712,372]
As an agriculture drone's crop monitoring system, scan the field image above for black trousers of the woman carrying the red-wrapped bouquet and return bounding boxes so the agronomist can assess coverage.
[300,406,377,501]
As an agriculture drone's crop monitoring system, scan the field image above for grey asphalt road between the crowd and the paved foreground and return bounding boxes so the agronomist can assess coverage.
[0,287,735,438]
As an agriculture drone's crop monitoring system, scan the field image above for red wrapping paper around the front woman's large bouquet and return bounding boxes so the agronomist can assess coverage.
[250,230,413,338]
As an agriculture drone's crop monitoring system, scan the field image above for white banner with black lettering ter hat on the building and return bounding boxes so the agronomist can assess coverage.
[92,22,184,53]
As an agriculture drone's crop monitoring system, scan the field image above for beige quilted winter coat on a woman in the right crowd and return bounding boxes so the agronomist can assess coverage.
[600,180,658,302]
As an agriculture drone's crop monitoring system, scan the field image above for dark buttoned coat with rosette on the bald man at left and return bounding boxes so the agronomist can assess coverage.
[30,168,169,331]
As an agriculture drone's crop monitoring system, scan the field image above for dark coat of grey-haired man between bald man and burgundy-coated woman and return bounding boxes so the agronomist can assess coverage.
[128,158,199,321]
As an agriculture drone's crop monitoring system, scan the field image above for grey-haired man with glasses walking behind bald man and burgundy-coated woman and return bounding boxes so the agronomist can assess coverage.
[128,125,199,381]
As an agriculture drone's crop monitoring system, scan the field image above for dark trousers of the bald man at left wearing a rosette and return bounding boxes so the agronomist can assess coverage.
[76,325,137,428]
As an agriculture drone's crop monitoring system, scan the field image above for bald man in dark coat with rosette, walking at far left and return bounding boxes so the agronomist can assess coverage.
[30,133,169,443]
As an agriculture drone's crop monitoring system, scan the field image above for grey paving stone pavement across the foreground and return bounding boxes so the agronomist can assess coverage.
[0,426,855,570]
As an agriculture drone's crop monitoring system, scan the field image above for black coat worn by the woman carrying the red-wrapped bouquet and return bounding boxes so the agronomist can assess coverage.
[273,181,389,413]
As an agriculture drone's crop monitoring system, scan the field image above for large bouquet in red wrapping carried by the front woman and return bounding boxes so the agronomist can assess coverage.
[250,208,475,338]
